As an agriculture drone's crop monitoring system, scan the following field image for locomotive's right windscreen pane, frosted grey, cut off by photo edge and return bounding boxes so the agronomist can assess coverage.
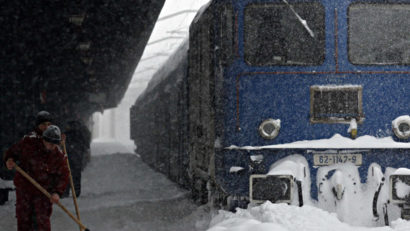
[348,3,410,65]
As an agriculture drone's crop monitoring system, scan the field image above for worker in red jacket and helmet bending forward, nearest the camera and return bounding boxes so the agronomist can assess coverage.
[5,125,69,231]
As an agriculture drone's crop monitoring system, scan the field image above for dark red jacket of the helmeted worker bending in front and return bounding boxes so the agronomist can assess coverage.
[4,135,69,196]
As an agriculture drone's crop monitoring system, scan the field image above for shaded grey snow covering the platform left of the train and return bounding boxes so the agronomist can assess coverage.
[0,143,211,231]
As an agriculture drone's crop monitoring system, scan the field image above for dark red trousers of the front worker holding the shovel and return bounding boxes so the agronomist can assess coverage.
[16,188,53,231]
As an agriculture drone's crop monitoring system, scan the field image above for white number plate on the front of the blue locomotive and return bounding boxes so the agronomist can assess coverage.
[313,153,362,166]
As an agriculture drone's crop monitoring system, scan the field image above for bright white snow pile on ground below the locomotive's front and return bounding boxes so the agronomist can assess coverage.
[208,201,410,231]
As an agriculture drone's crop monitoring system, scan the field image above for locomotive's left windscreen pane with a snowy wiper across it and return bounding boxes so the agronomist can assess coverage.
[244,2,325,66]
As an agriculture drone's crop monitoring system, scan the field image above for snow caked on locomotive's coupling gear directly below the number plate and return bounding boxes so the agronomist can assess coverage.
[316,163,386,227]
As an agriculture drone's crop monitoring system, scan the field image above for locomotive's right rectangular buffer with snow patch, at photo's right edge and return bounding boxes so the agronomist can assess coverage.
[390,174,410,203]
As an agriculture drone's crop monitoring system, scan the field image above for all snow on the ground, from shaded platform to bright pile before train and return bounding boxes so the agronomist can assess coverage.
[0,142,410,231]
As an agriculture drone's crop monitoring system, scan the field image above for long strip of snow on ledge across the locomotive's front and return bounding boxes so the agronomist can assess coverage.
[227,134,410,150]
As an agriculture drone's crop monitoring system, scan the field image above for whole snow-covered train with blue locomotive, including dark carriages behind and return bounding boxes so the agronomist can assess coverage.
[131,0,410,225]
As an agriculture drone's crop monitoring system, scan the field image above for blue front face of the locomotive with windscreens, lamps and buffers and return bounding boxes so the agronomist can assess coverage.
[215,0,410,224]
